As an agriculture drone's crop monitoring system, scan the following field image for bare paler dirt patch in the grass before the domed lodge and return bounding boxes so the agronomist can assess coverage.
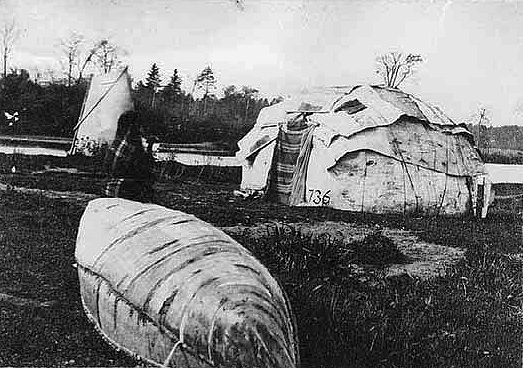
[221,221,465,279]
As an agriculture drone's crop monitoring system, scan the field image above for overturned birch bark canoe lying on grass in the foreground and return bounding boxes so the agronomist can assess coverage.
[76,198,299,368]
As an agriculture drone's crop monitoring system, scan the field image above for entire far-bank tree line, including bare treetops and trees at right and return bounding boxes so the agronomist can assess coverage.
[11,47,523,151]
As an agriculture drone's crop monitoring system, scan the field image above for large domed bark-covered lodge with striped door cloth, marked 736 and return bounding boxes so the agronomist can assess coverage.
[237,86,484,214]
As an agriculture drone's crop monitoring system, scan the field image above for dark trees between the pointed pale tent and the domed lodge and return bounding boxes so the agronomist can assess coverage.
[133,63,280,146]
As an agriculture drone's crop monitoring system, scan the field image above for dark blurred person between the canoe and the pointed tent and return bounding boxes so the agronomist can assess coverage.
[102,111,153,202]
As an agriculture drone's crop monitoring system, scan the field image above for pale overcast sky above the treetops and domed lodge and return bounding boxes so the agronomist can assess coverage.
[0,0,523,125]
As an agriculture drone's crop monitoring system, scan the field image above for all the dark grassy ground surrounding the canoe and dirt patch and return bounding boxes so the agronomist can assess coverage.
[0,154,523,368]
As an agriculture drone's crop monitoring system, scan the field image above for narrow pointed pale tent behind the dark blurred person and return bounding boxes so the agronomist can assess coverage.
[71,68,134,154]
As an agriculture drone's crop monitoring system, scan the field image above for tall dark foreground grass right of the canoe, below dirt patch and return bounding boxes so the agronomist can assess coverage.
[239,231,522,367]
